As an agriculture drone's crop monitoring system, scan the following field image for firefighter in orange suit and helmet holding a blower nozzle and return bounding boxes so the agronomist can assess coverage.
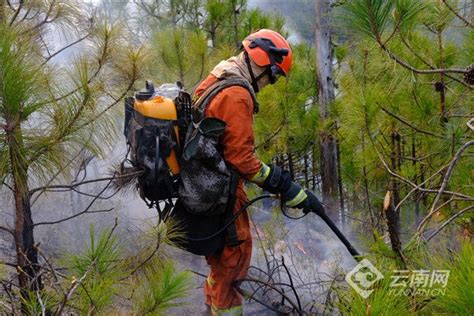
[195,29,323,315]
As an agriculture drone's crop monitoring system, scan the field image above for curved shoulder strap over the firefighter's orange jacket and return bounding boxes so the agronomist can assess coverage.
[194,78,258,113]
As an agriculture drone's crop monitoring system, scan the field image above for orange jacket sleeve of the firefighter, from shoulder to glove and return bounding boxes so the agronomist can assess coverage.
[205,86,262,180]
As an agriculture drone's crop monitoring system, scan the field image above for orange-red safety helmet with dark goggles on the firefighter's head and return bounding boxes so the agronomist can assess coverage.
[242,29,293,76]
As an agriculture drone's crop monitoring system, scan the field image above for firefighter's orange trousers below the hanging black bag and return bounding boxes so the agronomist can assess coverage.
[204,199,252,315]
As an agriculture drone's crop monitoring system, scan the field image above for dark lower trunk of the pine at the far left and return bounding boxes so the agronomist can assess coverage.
[7,120,42,298]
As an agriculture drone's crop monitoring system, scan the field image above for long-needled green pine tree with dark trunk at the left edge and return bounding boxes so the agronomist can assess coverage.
[0,0,143,306]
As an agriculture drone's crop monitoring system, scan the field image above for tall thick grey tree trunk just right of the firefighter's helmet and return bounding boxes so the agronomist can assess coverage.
[315,0,338,220]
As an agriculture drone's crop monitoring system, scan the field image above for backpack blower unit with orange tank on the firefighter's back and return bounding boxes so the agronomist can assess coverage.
[121,81,192,220]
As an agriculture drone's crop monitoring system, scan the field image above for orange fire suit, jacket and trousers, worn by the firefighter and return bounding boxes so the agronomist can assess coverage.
[195,74,264,315]
